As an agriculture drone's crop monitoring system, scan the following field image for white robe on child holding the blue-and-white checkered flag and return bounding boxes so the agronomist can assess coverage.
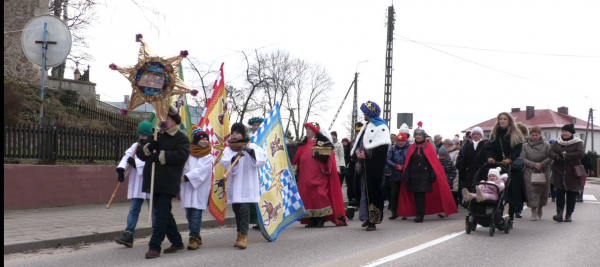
[221,144,268,204]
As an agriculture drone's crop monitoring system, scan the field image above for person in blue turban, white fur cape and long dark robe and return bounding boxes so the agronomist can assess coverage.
[351,101,391,231]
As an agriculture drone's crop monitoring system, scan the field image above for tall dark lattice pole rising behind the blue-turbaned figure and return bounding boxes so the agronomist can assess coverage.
[383,6,396,128]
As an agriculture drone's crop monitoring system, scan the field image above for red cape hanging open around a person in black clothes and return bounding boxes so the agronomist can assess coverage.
[398,143,458,217]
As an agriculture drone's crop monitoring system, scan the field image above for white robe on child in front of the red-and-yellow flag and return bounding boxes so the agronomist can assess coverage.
[181,154,214,210]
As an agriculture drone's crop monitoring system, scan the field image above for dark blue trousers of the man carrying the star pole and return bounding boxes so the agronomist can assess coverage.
[149,194,183,251]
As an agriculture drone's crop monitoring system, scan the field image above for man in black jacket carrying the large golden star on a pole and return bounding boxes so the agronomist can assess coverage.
[137,106,190,259]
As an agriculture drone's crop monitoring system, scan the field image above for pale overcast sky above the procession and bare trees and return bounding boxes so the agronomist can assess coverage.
[89,0,600,138]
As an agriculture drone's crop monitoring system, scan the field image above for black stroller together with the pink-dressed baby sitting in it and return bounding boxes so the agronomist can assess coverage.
[462,163,512,236]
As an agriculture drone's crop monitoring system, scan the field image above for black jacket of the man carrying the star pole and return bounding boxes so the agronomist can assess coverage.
[136,127,190,197]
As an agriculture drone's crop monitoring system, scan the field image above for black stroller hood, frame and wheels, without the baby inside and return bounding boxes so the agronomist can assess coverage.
[465,163,513,236]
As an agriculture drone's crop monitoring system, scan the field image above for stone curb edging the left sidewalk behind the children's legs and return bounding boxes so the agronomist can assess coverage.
[4,217,235,255]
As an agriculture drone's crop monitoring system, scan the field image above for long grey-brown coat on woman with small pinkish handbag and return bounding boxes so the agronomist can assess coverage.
[521,140,552,208]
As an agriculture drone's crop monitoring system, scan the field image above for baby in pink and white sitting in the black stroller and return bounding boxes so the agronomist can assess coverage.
[462,167,508,202]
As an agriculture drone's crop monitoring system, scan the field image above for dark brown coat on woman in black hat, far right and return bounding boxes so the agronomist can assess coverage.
[548,137,585,191]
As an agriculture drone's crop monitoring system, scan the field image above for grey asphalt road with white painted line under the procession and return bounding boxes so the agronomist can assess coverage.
[4,183,600,267]
